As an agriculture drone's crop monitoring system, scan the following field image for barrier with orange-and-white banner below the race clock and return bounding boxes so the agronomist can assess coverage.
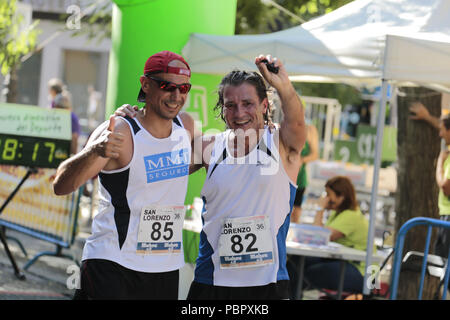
[0,165,82,270]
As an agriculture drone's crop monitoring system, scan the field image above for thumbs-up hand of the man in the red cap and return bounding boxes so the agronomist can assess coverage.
[94,115,124,159]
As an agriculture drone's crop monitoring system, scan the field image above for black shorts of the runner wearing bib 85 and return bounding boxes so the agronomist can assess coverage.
[73,259,179,300]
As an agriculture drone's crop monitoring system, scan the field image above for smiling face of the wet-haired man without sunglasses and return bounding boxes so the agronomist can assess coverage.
[223,83,267,131]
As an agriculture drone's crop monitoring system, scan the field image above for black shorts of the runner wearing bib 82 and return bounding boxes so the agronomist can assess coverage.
[187,280,289,300]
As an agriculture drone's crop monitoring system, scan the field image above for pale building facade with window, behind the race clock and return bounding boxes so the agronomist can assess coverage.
[18,0,111,136]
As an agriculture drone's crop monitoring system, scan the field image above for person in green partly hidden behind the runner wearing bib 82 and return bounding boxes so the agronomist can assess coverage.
[291,124,319,223]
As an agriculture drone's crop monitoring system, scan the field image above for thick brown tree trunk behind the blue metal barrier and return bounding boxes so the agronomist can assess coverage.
[395,87,441,299]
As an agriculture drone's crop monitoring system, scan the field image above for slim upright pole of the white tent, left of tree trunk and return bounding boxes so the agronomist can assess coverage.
[363,79,388,296]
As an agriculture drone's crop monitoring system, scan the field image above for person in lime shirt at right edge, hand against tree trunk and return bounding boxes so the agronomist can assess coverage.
[409,102,450,258]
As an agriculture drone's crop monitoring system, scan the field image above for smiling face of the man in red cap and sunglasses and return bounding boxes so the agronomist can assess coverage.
[141,60,190,119]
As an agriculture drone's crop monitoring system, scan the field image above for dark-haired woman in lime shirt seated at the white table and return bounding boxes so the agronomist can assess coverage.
[288,176,369,295]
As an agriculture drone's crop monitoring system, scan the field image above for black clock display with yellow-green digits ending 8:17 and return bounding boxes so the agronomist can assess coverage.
[0,134,70,168]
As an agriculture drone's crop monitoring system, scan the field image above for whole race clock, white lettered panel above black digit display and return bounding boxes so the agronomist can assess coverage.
[0,103,72,168]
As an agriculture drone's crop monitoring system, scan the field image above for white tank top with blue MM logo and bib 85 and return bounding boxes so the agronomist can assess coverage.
[83,117,191,272]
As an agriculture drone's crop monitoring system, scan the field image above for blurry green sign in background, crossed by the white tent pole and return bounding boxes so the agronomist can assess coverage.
[334,125,397,164]
